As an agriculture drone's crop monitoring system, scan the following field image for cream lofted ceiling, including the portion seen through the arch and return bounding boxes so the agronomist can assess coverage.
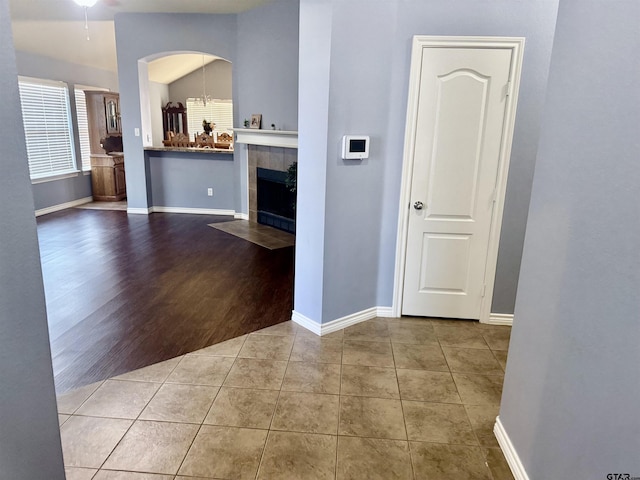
[9,0,271,78]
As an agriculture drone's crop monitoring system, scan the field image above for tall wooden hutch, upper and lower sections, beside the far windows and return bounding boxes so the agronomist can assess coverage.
[84,91,127,201]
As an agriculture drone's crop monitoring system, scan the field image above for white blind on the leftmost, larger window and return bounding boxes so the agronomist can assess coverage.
[19,78,77,179]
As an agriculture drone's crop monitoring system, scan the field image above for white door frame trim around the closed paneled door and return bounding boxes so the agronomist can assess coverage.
[393,35,525,323]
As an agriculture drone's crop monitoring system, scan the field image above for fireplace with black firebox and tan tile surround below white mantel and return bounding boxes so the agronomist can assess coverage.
[248,145,298,233]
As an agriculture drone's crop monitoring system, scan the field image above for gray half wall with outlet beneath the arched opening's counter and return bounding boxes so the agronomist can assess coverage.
[146,151,235,210]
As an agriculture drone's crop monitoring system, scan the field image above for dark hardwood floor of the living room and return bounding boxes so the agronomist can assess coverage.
[38,209,294,393]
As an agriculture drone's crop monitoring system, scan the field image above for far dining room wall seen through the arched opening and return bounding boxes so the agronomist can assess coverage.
[169,60,233,105]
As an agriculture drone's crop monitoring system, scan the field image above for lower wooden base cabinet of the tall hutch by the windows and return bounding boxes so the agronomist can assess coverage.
[91,153,127,202]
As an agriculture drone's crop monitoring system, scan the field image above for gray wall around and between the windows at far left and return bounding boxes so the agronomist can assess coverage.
[16,48,118,210]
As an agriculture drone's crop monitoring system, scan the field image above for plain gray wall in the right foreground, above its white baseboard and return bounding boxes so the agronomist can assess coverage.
[500,0,640,480]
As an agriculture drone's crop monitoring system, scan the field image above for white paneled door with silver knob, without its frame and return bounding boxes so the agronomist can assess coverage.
[402,40,514,319]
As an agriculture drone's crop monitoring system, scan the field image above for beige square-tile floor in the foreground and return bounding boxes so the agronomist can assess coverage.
[58,318,513,480]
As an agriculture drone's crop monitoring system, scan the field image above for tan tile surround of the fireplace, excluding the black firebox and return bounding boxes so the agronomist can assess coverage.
[248,145,298,222]
